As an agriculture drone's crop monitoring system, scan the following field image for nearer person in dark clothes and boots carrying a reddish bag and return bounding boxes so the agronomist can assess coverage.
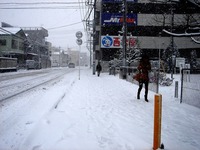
[137,55,151,102]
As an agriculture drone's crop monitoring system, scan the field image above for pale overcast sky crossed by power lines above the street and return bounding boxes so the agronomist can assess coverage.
[0,0,87,51]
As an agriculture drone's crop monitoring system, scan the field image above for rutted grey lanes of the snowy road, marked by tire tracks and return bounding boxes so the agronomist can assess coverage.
[0,69,70,101]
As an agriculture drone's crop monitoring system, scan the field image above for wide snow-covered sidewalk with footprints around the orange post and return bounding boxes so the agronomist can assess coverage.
[0,68,200,150]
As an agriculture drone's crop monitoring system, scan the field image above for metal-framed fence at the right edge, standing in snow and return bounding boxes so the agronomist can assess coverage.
[180,69,200,108]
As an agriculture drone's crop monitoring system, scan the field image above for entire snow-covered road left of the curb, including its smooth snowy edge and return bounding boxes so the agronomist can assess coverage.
[0,68,74,150]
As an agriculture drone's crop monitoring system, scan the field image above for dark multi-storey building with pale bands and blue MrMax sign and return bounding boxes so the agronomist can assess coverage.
[93,0,200,69]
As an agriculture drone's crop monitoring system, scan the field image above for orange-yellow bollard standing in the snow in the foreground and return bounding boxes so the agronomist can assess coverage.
[153,94,162,150]
